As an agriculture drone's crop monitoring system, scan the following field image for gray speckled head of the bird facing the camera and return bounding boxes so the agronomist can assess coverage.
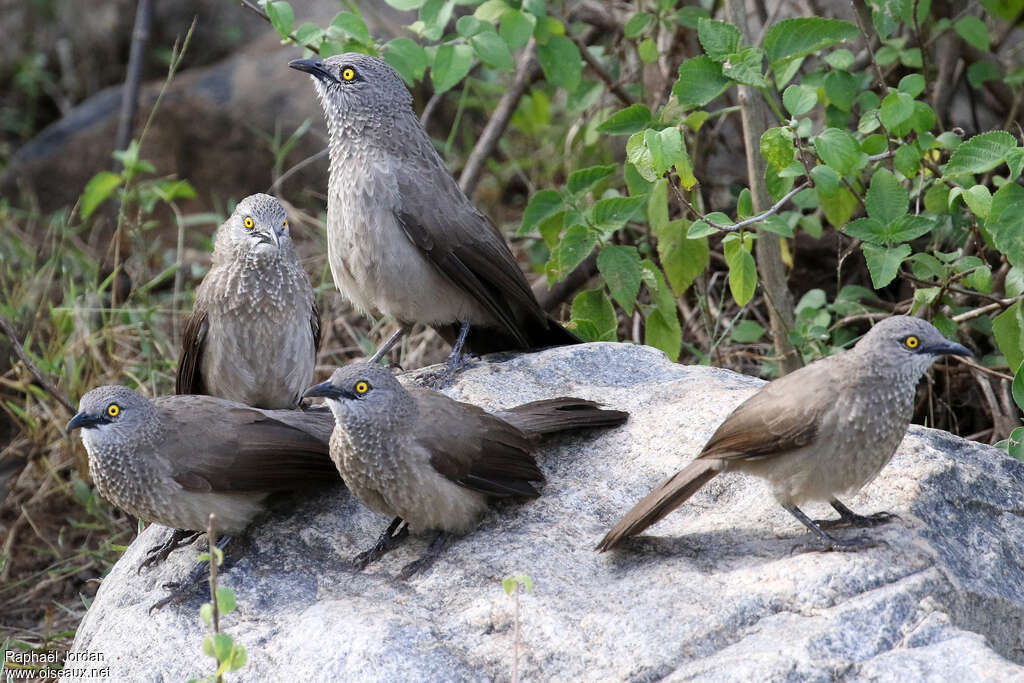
[213,195,292,263]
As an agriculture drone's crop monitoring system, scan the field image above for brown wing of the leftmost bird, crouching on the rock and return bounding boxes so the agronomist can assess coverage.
[158,396,339,492]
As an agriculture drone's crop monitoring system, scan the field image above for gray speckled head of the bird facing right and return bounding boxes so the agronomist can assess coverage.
[854,315,971,381]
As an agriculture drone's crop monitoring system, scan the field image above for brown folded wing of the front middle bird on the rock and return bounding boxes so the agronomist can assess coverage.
[413,389,544,498]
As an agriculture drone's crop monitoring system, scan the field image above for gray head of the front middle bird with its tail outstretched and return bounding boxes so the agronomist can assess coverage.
[305,362,416,425]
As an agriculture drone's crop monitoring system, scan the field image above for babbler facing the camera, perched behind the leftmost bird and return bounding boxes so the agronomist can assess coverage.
[175,195,319,409]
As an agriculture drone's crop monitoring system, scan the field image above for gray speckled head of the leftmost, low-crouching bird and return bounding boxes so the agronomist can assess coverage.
[68,385,160,449]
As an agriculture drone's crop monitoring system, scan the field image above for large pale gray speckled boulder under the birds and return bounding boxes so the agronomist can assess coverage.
[61,344,1024,681]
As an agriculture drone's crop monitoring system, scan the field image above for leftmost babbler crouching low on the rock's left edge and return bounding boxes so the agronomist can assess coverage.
[67,386,338,605]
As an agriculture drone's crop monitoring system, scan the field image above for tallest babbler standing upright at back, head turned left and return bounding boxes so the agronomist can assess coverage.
[289,52,580,375]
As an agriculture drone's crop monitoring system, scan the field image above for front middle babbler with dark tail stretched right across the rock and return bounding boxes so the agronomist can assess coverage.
[305,364,629,579]
